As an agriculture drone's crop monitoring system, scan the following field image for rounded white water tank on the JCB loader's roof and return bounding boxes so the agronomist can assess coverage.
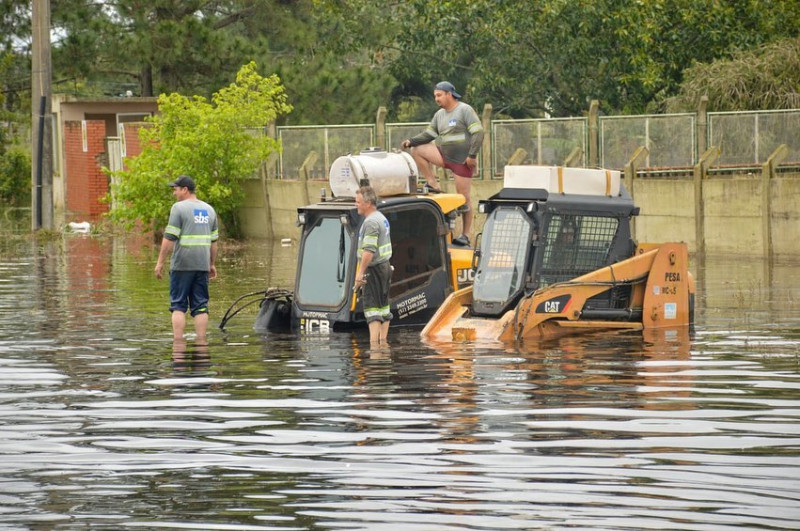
[328,148,419,197]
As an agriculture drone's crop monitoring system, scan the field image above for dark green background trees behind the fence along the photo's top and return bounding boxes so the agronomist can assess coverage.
[6,0,800,124]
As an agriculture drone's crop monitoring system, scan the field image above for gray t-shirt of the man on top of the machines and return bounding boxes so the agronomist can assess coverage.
[411,102,484,164]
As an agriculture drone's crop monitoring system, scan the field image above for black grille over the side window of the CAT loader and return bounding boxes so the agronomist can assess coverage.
[539,214,619,287]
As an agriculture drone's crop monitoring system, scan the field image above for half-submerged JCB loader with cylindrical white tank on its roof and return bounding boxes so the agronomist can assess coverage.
[241,148,473,335]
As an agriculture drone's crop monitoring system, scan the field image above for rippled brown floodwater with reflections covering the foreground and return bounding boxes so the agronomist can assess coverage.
[0,235,800,530]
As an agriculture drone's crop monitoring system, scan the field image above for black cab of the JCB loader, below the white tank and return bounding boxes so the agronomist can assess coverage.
[291,196,463,333]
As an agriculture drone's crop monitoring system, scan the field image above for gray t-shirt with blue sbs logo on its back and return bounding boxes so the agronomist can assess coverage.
[164,199,219,271]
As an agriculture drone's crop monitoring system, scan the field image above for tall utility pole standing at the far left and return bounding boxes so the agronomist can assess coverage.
[31,0,54,231]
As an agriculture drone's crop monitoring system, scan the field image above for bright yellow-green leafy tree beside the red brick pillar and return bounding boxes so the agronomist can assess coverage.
[109,62,292,237]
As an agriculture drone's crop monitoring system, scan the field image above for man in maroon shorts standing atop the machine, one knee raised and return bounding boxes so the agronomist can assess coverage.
[401,81,484,245]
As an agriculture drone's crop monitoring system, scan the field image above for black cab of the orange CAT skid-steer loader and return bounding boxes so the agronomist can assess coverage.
[471,187,638,316]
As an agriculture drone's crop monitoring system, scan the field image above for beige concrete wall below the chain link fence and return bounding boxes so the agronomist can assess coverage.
[240,170,800,259]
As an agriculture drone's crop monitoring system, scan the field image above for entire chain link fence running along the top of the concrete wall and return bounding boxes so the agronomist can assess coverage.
[275,110,800,180]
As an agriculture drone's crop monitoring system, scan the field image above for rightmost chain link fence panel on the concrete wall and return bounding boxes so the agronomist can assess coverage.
[708,110,800,167]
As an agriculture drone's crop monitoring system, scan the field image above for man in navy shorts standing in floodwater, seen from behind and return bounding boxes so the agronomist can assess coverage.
[155,175,219,344]
